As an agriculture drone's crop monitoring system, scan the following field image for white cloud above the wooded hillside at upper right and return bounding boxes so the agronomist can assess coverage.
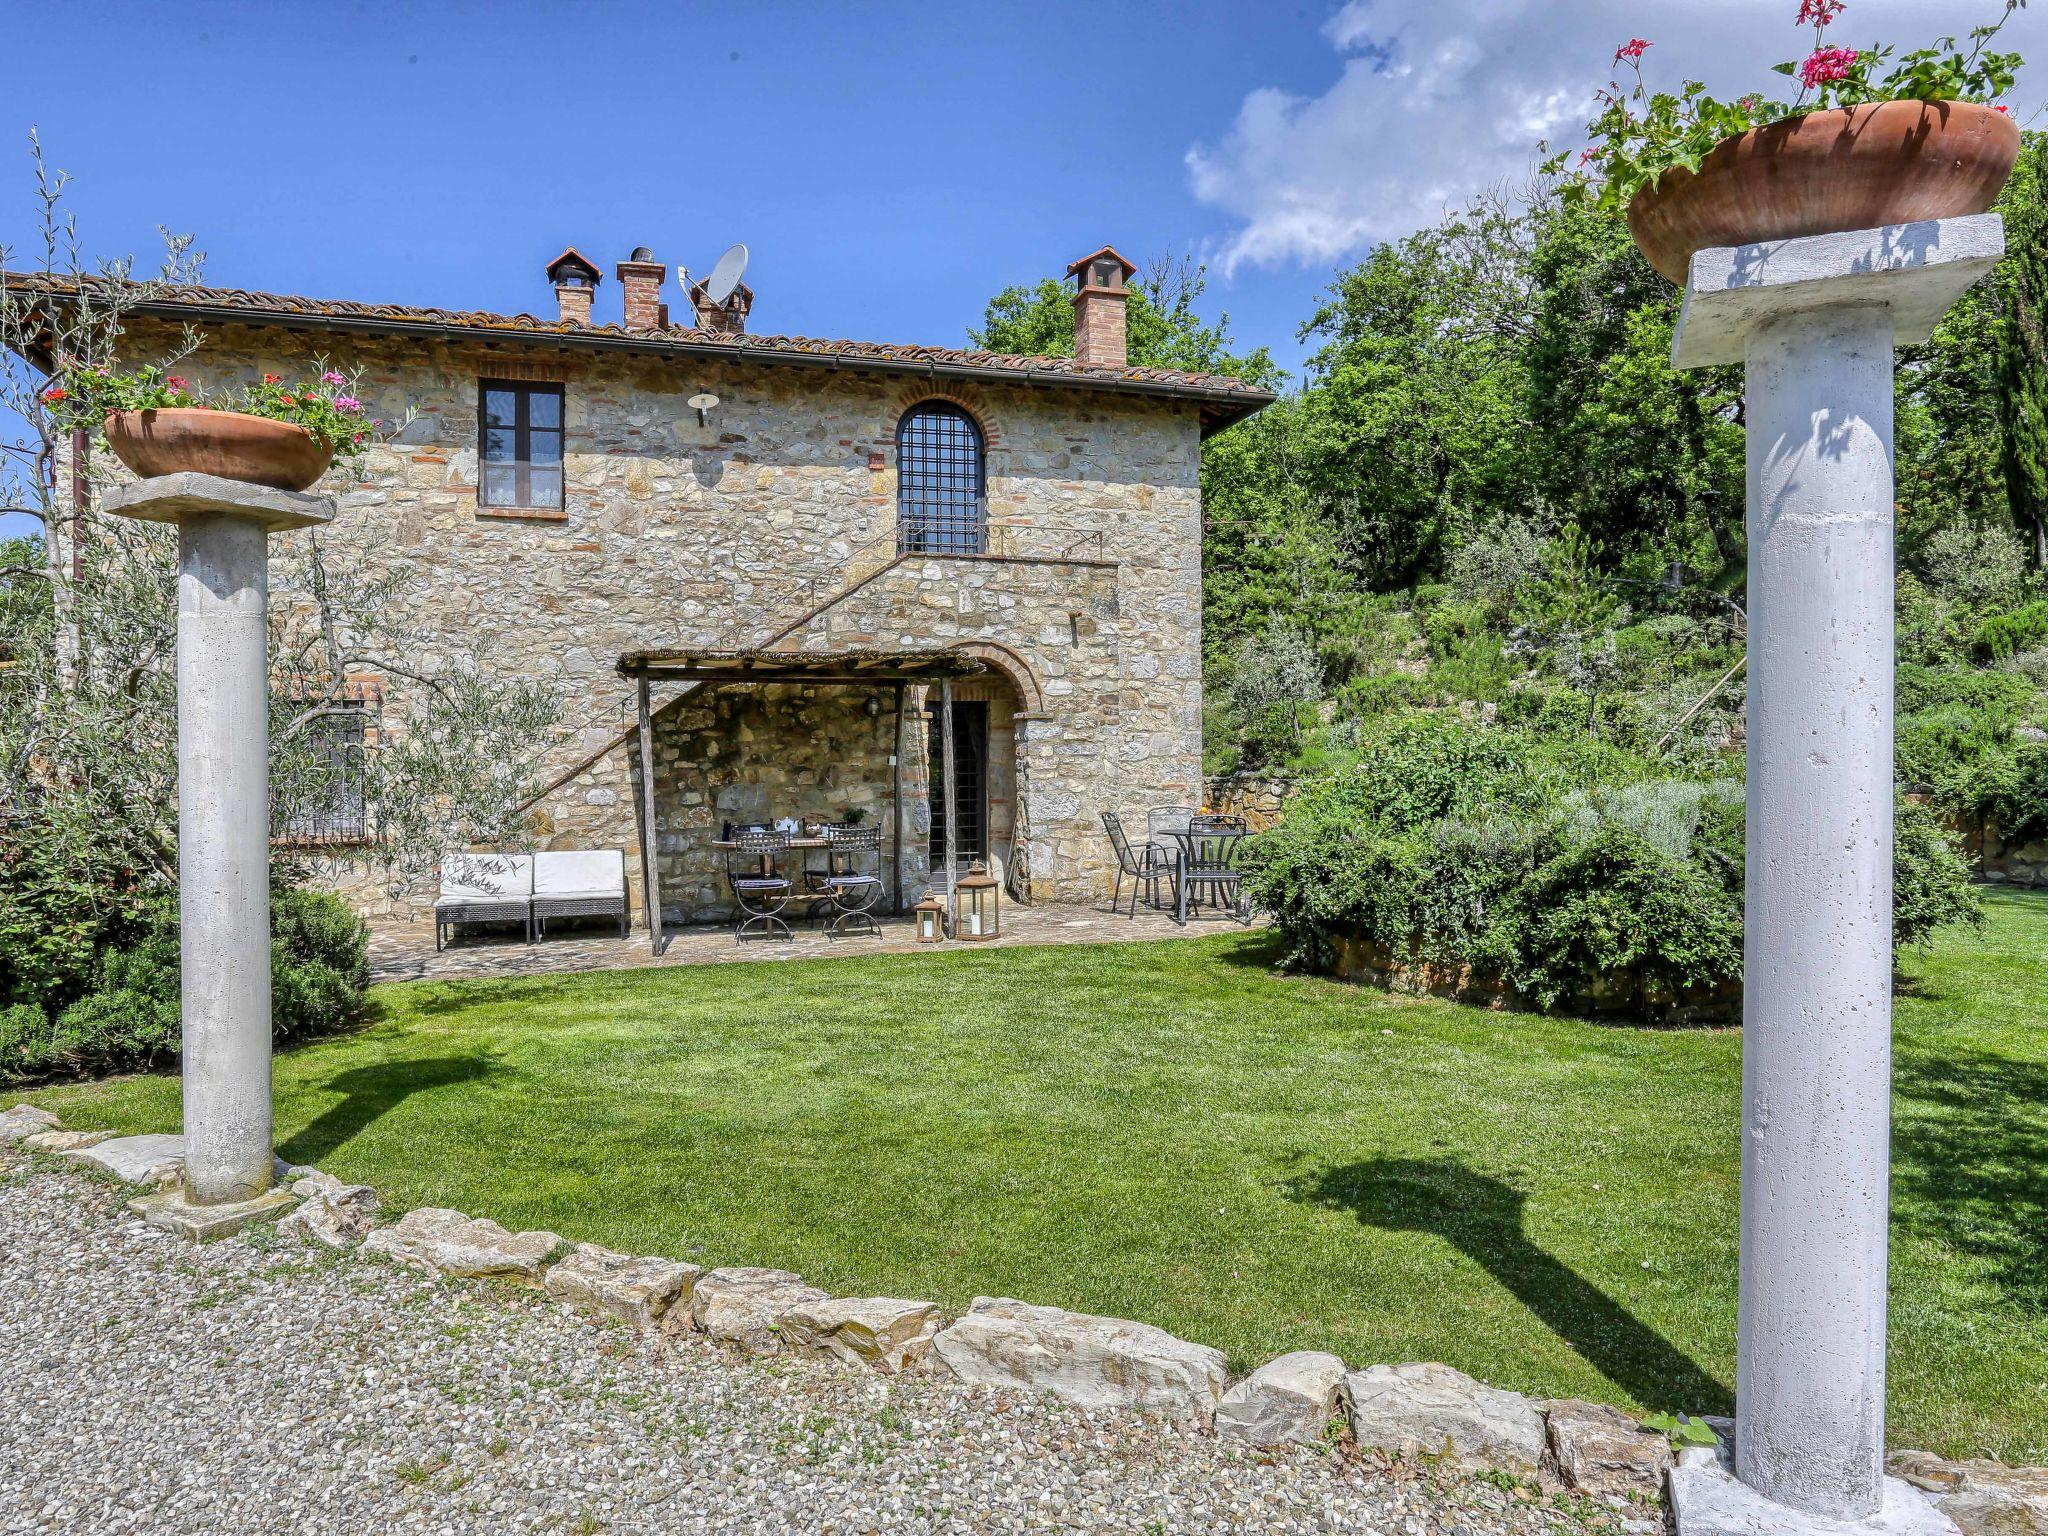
[1188,0,2048,270]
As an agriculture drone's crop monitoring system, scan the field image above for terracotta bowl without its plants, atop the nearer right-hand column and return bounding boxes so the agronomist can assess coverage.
[1628,100,2019,287]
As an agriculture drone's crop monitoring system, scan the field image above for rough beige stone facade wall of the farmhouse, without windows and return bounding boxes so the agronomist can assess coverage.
[99,324,1200,911]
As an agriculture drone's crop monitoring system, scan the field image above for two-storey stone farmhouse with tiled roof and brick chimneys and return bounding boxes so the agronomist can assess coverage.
[68,248,1272,924]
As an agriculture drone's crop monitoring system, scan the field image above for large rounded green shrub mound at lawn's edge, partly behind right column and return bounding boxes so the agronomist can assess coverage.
[1245,715,1982,1018]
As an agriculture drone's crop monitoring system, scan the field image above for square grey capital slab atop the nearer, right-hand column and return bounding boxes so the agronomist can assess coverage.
[1671,213,2005,369]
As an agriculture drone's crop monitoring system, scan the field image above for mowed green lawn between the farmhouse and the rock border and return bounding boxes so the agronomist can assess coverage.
[33,895,2048,1462]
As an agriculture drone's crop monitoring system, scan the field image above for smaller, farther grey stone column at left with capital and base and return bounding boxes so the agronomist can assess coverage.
[102,473,334,1235]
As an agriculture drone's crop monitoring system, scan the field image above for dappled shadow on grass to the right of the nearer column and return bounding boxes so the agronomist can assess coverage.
[1892,1040,2048,1309]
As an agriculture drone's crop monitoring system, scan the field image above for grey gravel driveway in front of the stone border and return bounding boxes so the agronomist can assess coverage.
[0,1153,1630,1536]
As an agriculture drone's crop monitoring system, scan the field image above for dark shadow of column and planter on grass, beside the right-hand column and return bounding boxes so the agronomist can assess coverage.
[1290,1157,1735,1413]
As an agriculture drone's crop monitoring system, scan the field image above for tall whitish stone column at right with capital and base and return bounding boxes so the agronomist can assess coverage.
[1671,215,2005,1536]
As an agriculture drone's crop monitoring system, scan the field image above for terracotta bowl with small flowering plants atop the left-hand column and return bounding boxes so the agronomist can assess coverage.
[43,365,377,492]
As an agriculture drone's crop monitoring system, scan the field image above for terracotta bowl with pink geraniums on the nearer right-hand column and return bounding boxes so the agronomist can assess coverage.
[1546,0,2025,287]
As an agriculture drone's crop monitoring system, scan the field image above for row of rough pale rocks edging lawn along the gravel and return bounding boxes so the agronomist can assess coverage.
[12,1104,2048,1536]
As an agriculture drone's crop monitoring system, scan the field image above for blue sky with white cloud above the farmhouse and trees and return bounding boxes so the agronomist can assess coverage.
[0,0,2048,544]
